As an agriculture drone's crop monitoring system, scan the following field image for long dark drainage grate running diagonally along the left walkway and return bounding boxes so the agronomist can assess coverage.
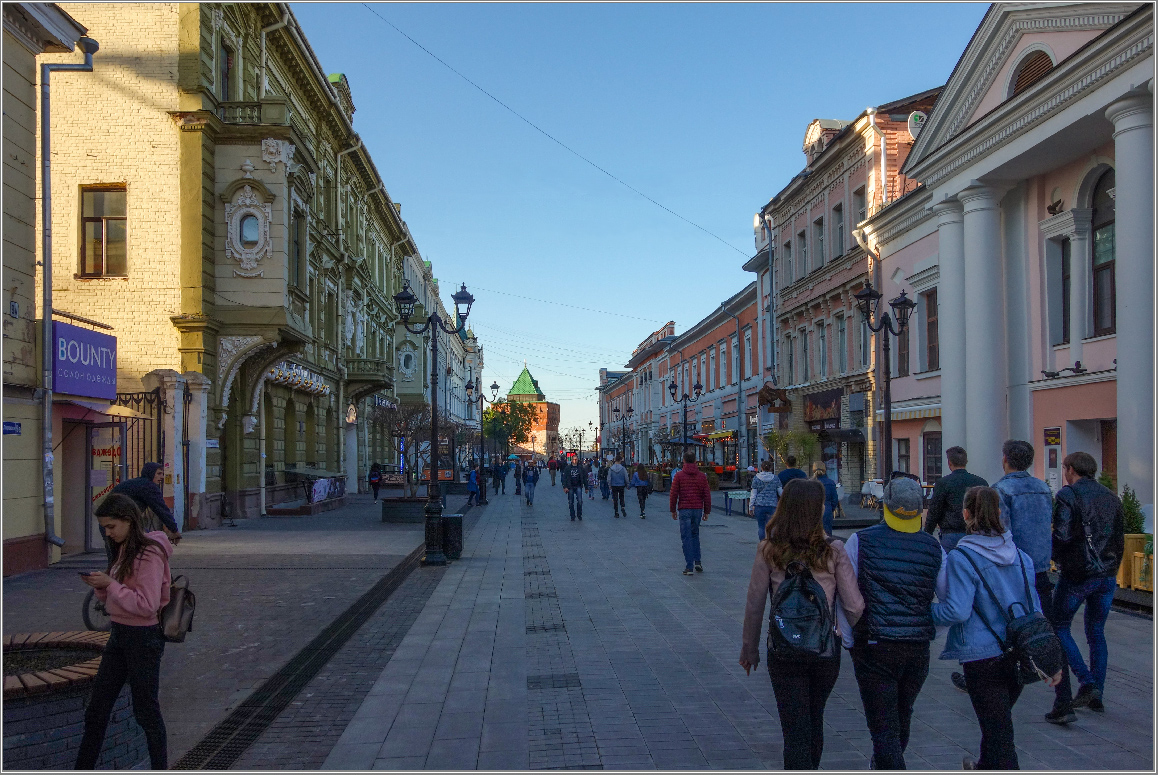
[173,546,426,769]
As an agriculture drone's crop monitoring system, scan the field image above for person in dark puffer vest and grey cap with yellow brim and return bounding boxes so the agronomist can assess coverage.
[838,477,945,769]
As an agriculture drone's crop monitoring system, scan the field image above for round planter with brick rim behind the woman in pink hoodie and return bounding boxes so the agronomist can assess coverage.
[3,633,148,770]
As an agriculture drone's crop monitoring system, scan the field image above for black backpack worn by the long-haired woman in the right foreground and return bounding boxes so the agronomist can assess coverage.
[768,560,837,661]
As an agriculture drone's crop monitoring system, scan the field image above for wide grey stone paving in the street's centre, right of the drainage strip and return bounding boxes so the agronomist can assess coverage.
[324,487,1153,770]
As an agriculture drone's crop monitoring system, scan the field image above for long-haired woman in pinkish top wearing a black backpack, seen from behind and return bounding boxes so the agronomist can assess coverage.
[740,478,865,769]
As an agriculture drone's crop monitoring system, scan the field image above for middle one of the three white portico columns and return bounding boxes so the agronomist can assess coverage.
[958,183,1009,482]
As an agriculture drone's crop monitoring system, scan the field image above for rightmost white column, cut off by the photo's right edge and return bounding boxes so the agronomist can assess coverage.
[1106,94,1155,529]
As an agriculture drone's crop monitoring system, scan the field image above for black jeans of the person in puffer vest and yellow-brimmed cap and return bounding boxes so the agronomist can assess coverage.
[851,641,929,769]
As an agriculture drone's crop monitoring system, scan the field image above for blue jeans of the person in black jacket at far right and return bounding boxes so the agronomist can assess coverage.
[1051,577,1117,707]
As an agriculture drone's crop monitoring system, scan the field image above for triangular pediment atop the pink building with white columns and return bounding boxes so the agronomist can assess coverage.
[904,2,1142,171]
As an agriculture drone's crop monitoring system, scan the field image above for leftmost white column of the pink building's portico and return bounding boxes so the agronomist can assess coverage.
[933,199,968,451]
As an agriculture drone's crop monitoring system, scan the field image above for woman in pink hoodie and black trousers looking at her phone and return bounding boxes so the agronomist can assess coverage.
[76,492,173,769]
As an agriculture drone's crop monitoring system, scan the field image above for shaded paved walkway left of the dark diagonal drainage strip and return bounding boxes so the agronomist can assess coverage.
[3,496,423,761]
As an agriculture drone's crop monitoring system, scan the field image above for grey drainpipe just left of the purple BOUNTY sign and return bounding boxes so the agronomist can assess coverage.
[41,37,101,547]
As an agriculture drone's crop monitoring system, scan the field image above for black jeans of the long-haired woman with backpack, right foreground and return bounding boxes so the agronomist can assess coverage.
[768,651,841,769]
